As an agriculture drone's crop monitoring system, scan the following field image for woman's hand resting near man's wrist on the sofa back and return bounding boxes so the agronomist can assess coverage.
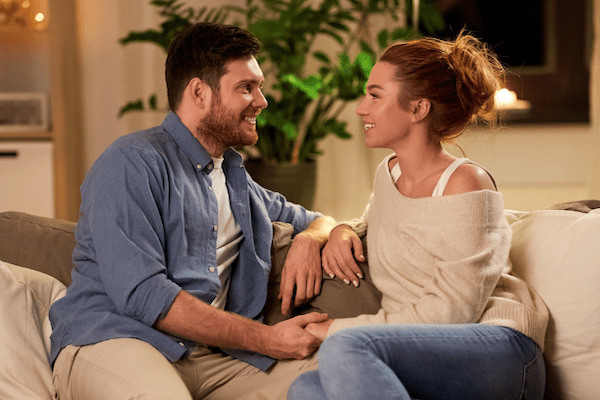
[321,225,366,287]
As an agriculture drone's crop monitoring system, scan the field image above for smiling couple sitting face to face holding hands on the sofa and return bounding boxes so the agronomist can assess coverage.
[50,23,548,400]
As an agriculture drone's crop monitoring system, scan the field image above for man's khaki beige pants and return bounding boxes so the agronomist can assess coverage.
[53,339,318,400]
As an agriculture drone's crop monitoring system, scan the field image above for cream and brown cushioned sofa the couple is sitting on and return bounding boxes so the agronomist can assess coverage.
[0,200,600,400]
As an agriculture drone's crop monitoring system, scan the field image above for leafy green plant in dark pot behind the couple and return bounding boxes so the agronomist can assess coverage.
[121,0,443,208]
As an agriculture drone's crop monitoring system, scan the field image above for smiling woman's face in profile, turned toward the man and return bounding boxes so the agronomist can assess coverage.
[356,62,413,149]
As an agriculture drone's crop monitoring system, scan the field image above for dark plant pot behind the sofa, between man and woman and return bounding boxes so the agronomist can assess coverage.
[245,160,317,210]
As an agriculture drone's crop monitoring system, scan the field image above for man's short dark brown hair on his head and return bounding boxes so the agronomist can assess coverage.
[165,22,260,111]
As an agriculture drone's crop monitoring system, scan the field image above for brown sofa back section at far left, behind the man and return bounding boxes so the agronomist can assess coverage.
[0,211,77,286]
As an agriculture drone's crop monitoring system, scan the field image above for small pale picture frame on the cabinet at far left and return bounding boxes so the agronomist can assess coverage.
[0,92,49,133]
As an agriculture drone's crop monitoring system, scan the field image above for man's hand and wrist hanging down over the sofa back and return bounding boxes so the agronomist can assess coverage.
[279,217,336,314]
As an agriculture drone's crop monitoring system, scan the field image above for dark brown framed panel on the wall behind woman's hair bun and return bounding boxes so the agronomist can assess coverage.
[435,0,593,124]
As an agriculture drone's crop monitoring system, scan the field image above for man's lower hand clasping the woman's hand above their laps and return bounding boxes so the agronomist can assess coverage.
[264,313,328,360]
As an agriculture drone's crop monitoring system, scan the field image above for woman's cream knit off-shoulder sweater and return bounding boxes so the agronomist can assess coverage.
[328,156,548,348]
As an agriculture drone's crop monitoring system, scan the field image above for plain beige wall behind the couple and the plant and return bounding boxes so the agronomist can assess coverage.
[78,0,600,219]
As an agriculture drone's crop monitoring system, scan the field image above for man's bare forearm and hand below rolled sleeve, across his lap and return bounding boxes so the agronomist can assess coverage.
[154,290,327,359]
